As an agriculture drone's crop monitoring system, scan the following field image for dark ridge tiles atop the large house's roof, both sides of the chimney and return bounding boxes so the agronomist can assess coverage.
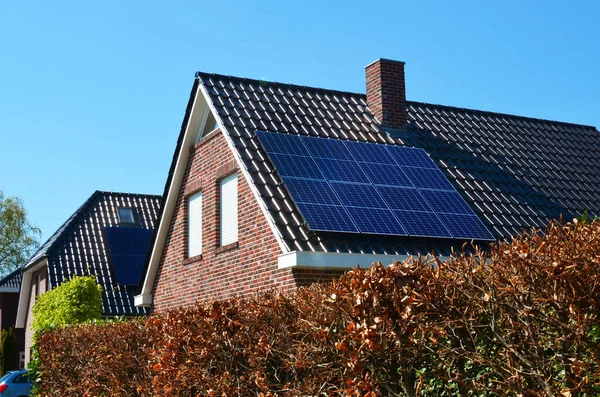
[196,69,598,131]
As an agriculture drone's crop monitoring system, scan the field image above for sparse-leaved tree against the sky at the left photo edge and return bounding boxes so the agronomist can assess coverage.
[0,190,40,274]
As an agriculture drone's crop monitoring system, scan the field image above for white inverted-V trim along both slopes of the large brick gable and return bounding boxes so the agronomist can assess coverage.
[134,77,288,307]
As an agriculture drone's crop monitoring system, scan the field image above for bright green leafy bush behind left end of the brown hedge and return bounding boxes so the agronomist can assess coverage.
[32,276,102,334]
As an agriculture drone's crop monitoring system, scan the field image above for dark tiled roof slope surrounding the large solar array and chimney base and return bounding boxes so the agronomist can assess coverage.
[197,73,600,254]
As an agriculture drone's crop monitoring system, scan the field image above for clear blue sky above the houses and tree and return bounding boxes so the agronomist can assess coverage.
[0,0,600,243]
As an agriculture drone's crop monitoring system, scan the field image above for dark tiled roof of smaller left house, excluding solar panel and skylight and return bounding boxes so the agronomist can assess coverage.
[26,191,161,316]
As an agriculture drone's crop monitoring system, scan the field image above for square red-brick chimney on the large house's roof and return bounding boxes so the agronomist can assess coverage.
[365,59,408,132]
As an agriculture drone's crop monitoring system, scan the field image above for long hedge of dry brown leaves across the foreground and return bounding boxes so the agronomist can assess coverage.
[39,221,600,397]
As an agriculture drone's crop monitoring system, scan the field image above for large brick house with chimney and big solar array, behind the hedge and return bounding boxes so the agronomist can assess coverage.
[135,59,600,311]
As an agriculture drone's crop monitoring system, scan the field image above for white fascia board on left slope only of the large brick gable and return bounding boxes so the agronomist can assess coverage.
[134,84,206,307]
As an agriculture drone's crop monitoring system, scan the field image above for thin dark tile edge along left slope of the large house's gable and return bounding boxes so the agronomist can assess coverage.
[136,77,200,295]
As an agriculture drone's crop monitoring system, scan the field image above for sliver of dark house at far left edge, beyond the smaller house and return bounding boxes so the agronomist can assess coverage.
[0,268,25,368]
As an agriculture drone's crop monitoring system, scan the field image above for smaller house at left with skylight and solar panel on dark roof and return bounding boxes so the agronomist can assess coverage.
[16,191,160,362]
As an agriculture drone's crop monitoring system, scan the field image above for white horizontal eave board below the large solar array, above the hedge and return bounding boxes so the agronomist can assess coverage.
[277,251,410,269]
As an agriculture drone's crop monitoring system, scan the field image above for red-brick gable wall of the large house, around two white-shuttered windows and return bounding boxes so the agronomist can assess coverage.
[153,130,340,311]
